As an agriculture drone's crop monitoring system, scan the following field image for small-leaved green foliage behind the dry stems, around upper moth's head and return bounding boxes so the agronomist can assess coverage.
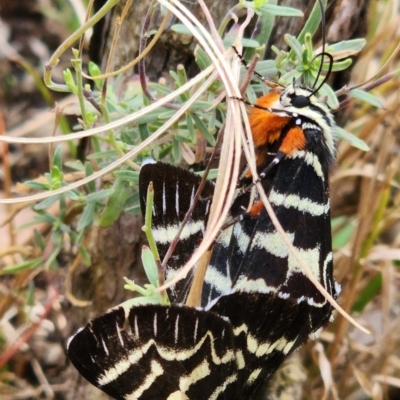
[6,0,374,282]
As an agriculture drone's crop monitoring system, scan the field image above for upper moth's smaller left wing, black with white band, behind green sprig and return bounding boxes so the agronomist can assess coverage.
[139,162,214,302]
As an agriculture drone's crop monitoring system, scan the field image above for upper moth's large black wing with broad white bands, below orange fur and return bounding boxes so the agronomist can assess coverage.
[203,138,337,334]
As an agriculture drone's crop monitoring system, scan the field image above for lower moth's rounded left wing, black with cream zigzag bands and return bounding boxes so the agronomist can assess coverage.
[68,305,237,400]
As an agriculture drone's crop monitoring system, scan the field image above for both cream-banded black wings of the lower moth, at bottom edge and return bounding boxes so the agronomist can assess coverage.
[68,292,310,400]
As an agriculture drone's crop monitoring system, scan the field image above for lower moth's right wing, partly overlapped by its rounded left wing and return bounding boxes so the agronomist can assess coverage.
[211,292,311,400]
